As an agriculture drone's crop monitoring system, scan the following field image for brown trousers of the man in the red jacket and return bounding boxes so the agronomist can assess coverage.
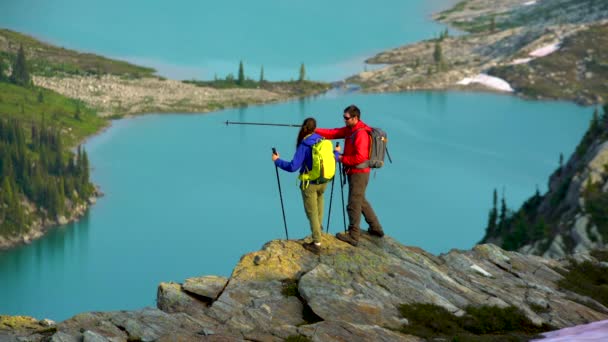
[346,172,382,239]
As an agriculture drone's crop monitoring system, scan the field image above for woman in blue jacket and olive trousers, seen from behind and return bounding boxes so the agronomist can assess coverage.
[272,118,337,254]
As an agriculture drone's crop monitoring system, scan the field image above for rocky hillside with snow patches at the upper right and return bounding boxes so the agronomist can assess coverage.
[349,0,608,104]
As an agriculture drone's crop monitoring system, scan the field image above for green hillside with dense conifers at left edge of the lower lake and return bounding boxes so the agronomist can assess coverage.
[0,81,106,249]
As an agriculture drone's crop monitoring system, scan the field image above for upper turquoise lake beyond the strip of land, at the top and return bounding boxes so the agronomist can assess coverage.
[0,0,453,81]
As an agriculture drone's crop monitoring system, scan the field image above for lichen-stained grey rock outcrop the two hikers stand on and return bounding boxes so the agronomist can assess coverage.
[0,234,608,341]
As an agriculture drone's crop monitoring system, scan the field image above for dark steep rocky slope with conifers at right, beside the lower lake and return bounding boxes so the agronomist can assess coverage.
[482,105,608,257]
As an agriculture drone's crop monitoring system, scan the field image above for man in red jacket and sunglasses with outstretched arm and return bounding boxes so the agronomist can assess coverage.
[315,105,384,246]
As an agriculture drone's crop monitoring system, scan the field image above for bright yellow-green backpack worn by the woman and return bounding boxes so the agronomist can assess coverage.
[298,139,336,189]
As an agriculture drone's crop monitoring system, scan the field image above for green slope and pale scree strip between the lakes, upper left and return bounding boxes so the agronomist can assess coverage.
[0,30,331,117]
